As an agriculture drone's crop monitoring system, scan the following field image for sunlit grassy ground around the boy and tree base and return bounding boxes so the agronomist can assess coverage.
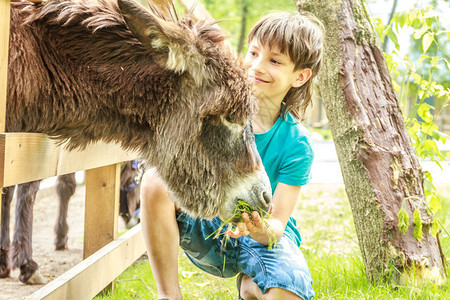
[96,184,450,299]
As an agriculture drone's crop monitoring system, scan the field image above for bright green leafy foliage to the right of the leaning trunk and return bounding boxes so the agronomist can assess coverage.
[374,2,450,238]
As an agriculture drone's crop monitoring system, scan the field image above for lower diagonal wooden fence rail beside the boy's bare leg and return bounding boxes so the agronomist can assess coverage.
[25,224,145,300]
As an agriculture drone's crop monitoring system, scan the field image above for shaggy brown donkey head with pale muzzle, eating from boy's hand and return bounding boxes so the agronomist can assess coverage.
[118,0,272,219]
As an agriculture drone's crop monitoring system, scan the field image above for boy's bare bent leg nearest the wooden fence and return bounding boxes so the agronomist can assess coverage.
[141,170,182,300]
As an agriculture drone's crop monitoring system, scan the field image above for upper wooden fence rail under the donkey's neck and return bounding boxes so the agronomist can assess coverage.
[0,133,138,187]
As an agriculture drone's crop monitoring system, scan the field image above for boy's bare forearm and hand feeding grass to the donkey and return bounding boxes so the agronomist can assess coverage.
[228,182,301,245]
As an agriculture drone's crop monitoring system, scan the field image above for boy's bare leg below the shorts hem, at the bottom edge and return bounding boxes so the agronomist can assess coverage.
[241,274,302,300]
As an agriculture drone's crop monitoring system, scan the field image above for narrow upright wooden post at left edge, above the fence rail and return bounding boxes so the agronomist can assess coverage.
[0,0,11,132]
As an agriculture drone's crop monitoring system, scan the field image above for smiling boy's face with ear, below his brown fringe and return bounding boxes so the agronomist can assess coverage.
[244,40,309,105]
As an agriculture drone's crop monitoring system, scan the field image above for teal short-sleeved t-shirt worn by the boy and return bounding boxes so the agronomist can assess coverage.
[255,113,314,247]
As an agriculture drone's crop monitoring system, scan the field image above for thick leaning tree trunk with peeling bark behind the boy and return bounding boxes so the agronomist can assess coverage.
[296,0,446,284]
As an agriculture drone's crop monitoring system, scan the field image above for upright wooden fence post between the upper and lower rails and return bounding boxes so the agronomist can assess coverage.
[83,164,120,259]
